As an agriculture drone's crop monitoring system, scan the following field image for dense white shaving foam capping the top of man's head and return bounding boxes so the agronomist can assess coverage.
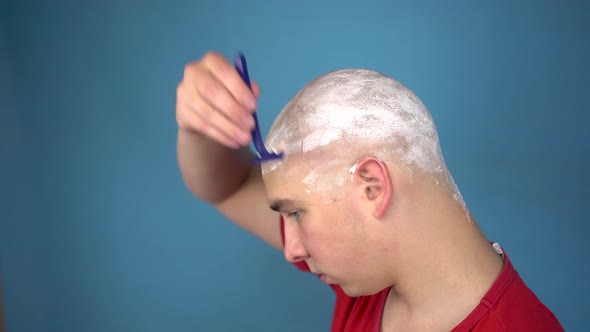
[264,69,440,172]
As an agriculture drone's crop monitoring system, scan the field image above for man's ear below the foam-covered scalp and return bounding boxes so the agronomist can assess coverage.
[353,157,393,218]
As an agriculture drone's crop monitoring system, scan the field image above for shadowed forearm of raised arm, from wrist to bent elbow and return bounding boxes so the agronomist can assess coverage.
[177,129,252,204]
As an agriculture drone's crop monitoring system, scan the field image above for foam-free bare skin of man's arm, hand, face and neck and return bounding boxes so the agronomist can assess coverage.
[176,53,502,331]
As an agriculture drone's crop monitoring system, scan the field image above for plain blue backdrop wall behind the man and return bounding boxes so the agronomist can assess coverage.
[0,0,590,331]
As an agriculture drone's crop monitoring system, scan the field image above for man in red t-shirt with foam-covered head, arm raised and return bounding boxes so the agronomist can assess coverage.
[176,53,563,331]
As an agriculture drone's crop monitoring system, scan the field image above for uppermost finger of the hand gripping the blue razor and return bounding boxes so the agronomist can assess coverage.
[203,52,256,111]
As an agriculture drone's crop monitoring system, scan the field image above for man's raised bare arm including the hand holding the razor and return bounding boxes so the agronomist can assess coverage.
[176,52,282,249]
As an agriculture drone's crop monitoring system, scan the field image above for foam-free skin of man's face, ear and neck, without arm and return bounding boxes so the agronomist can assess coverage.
[265,158,502,331]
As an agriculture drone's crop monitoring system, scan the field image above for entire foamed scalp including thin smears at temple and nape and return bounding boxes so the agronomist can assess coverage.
[262,69,470,215]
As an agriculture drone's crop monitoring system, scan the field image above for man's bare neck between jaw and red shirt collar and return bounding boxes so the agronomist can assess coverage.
[384,182,502,330]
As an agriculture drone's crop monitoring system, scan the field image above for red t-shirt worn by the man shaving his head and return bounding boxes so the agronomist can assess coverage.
[281,218,563,332]
